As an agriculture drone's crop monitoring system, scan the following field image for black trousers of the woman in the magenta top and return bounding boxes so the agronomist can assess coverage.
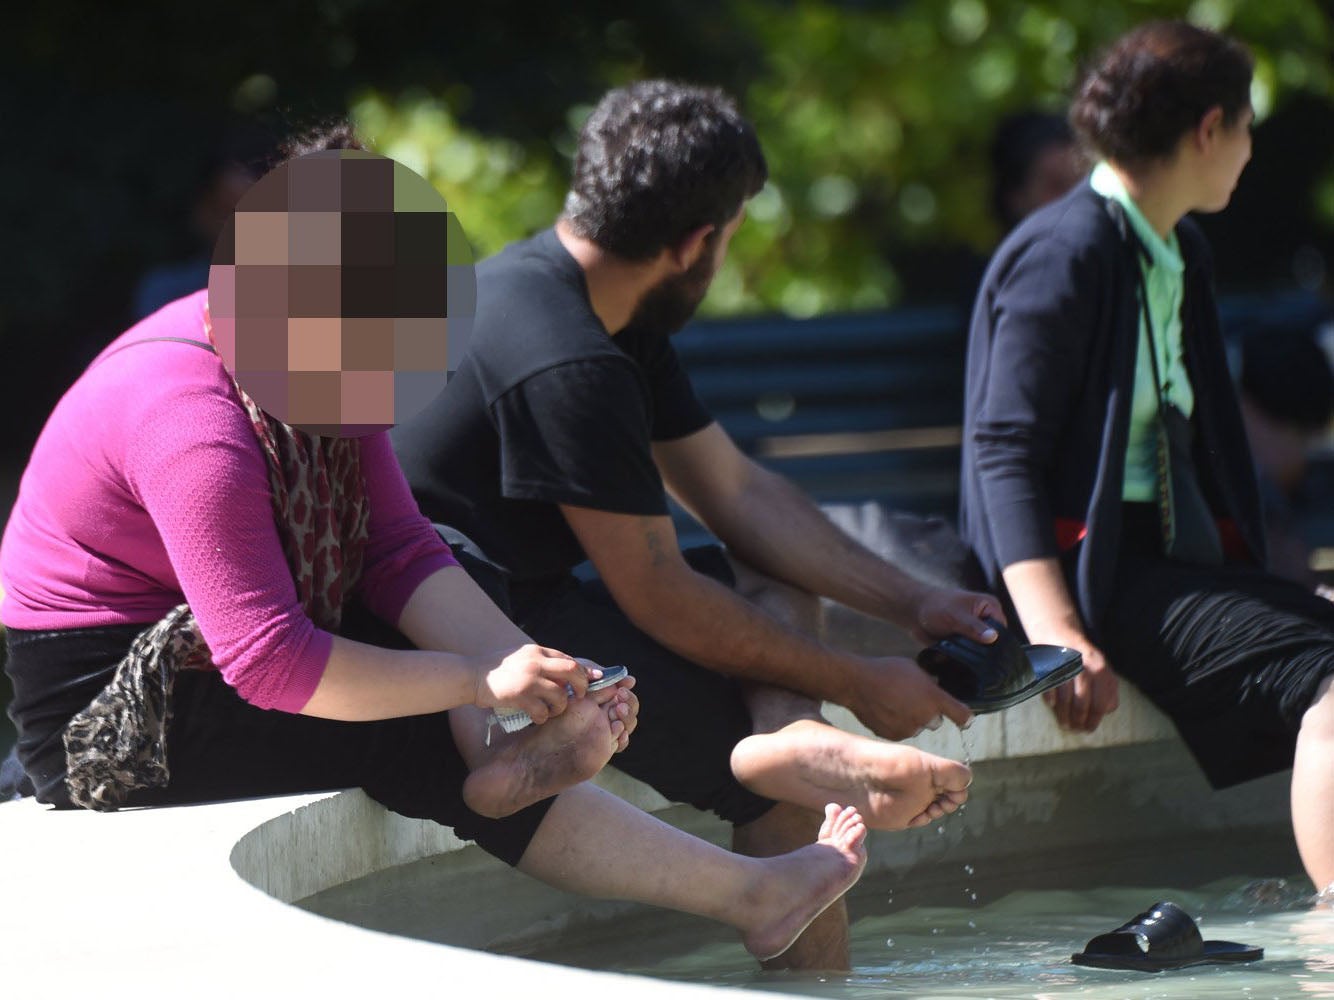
[5,600,551,865]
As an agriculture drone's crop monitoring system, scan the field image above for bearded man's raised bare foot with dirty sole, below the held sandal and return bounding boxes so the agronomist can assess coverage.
[732,719,972,829]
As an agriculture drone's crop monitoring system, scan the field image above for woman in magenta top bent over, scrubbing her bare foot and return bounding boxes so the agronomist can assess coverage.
[0,132,866,957]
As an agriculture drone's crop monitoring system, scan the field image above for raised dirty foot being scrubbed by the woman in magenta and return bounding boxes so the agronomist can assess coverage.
[463,688,632,819]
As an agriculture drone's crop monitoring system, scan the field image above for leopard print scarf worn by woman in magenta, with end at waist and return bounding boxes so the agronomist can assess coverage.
[64,322,370,811]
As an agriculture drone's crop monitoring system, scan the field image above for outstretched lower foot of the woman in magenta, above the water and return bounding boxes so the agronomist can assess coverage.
[742,803,866,961]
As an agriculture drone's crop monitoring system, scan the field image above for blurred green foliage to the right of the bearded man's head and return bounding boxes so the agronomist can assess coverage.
[731,0,1334,313]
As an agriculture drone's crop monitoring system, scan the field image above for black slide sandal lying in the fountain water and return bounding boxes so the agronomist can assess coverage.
[1070,900,1265,972]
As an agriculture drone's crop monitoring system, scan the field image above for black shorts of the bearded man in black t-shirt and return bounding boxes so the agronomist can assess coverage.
[510,545,774,825]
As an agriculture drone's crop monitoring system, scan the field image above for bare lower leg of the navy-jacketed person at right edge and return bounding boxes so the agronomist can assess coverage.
[1293,677,1334,901]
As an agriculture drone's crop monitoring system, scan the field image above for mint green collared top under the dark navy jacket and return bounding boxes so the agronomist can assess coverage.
[1089,163,1195,501]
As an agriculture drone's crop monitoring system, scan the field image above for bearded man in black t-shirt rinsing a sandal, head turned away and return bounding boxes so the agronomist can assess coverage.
[392,81,1001,968]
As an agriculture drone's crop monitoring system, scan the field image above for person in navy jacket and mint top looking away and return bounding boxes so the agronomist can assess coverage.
[960,21,1334,888]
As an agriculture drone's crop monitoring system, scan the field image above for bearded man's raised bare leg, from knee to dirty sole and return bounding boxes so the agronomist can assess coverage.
[730,559,972,832]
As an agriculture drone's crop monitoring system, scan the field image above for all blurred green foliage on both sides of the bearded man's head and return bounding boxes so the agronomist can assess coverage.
[351,0,1334,316]
